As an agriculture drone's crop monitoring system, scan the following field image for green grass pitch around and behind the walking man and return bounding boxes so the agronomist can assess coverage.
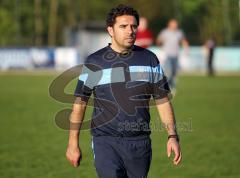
[0,74,240,178]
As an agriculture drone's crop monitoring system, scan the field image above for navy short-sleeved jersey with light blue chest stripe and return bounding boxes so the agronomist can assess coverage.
[75,46,170,137]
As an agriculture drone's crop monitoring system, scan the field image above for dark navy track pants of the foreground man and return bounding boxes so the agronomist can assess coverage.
[92,136,152,178]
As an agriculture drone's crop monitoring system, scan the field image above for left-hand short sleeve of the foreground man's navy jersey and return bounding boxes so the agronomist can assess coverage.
[74,64,94,102]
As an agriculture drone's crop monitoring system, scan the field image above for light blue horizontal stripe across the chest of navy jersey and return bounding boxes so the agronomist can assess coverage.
[79,65,163,88]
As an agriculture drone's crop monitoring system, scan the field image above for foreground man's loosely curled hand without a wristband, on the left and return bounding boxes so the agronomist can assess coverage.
[66,145,82,167]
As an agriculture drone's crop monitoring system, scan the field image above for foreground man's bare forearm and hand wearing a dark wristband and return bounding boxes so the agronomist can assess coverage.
[155,97,182,165]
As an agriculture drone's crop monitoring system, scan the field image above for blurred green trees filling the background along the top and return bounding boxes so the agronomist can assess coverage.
[0,0,240,46]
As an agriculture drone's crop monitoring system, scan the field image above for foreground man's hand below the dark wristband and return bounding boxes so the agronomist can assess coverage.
[167,138,182,165]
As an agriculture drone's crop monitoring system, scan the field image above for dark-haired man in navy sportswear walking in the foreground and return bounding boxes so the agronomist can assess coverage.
[66,5,181,178]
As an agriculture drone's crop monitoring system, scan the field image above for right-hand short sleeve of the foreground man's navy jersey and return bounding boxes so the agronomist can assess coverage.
[152,55,171,100]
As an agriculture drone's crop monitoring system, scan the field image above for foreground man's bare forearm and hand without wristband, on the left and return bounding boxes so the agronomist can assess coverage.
[66,97,86,167]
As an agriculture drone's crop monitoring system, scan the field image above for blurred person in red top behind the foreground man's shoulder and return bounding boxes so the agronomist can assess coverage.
[135,17,153,48]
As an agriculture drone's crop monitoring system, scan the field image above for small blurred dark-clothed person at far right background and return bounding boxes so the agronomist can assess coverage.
[204,38,216,76]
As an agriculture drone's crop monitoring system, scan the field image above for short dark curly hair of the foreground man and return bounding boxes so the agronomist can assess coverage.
[106,4,139,27]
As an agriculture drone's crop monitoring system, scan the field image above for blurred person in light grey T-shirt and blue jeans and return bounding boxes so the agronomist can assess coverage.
[156,19,188,93]
